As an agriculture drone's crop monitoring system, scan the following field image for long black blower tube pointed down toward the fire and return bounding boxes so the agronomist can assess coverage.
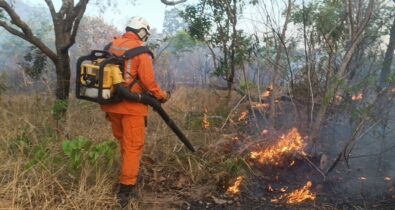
[116,85,195,152]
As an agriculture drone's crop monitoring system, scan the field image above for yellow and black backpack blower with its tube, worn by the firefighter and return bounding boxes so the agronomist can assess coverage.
[76,46,195,152]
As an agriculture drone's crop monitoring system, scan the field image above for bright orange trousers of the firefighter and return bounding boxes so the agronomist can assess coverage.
[106,112,145,185]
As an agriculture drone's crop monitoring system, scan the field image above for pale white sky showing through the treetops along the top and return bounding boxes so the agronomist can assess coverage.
[22,0,290,33]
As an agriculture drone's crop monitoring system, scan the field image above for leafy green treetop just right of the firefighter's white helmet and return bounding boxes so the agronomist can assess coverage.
[181,0,252,90]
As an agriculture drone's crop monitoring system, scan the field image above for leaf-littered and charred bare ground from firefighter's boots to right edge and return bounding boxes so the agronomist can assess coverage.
[135,158,395,210]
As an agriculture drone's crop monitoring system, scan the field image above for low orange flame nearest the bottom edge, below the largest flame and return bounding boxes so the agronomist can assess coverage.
[271,181,316,204]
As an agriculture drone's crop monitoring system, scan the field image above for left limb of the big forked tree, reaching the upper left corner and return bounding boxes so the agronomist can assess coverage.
[0,0,56,62]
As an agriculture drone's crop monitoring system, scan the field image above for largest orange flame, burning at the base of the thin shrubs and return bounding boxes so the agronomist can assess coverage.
[250,128,305,165]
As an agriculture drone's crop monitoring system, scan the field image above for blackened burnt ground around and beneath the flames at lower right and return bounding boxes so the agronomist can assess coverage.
[182,158,395,210]
